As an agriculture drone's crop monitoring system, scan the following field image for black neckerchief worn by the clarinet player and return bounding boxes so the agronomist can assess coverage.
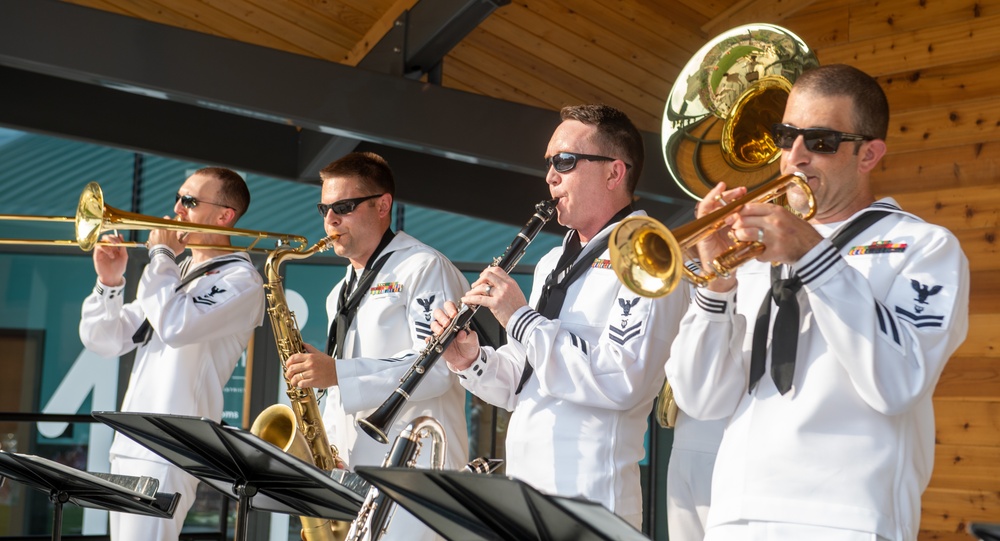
[514,204,634,394]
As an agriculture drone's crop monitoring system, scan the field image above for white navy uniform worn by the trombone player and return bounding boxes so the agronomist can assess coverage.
[80,245,264,539]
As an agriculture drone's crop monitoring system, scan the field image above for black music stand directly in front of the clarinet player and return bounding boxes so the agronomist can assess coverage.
[356,466,649,541]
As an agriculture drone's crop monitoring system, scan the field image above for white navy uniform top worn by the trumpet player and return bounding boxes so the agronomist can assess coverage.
[667,199,969,541]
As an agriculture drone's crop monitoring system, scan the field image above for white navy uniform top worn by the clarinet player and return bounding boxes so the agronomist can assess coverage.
[461,211,688,528]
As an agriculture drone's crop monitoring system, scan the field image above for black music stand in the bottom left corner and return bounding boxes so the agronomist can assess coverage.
[0,451,180,541]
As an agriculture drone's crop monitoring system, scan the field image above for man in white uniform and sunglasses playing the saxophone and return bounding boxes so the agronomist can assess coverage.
[285,152,469,540]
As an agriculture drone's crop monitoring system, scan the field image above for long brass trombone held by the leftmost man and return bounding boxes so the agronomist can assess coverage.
[0,182,307,253]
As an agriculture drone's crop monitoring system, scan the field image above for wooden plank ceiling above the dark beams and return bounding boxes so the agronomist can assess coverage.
[58,0,812,133]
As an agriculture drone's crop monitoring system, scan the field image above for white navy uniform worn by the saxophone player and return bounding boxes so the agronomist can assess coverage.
[323,231,469,540]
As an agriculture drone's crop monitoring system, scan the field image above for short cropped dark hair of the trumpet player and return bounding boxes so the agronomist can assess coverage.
[794,64,889,140]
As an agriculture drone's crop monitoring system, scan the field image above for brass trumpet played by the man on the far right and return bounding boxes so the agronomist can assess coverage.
[608,172,816,298]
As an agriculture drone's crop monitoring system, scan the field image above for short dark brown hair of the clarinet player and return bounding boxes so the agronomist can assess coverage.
[559,104,645,195]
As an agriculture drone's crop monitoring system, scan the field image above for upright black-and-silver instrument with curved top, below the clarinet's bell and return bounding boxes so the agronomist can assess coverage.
[347,416,448,541]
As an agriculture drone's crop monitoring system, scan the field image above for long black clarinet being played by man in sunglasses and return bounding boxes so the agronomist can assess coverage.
[357,199,558,443]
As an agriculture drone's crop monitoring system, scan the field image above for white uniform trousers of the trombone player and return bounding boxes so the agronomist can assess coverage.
[109,456,198,541]
